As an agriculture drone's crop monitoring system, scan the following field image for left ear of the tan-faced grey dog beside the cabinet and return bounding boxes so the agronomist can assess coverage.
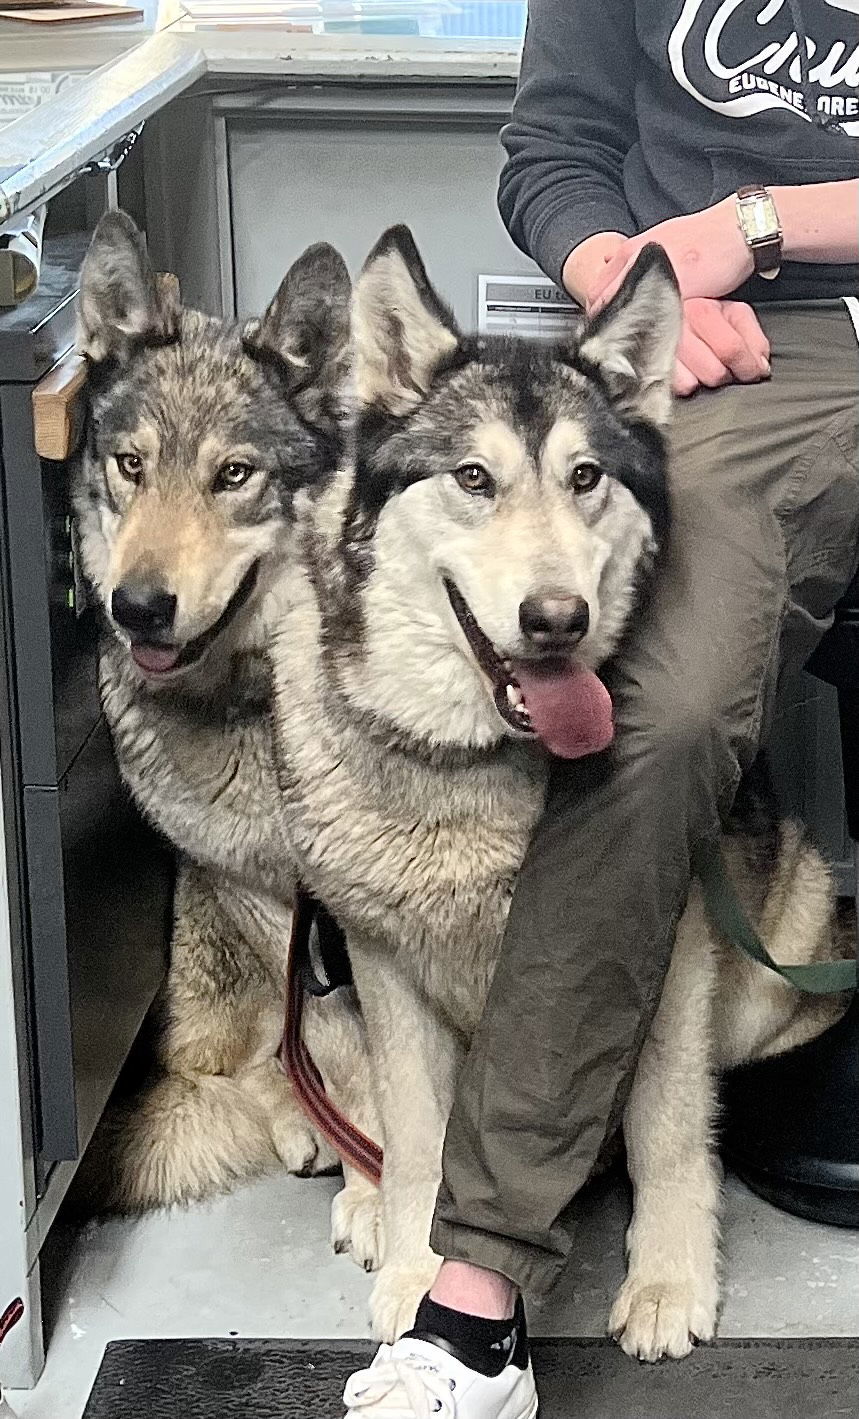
[77,211,179,363]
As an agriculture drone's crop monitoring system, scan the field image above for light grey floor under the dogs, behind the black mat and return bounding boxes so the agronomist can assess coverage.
[10,1176,859,1419]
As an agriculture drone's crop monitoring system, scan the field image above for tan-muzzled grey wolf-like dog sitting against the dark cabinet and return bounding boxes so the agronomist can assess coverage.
[74,213,376,1264]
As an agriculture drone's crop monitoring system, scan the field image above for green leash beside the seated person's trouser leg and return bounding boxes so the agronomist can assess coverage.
[691,843,858,995]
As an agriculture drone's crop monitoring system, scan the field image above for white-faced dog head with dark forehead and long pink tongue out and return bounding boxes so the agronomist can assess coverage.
[325,228,682,756]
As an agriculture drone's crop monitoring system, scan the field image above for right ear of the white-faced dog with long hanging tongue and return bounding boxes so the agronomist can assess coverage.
[578,243,683,426]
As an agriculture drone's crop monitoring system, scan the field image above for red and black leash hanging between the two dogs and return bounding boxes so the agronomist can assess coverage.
[280,887,382,1186]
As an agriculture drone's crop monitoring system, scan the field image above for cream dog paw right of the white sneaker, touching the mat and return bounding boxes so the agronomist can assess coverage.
[609,1277,718,1364]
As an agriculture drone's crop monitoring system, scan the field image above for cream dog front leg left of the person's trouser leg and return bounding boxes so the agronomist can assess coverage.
[349,941,463,1341]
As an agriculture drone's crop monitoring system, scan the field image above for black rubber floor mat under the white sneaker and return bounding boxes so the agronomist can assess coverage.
[84,1340,859,1419]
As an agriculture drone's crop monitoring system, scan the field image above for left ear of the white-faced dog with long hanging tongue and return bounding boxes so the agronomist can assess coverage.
[352,227,461,414]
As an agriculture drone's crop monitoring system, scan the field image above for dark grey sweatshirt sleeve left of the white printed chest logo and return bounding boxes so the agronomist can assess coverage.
[498,0,639,285]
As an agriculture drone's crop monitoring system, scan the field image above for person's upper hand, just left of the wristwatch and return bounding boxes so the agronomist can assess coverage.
[588,197,754,311]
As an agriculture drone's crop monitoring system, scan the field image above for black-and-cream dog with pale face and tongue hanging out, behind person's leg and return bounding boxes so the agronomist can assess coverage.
[273,228,838,1359]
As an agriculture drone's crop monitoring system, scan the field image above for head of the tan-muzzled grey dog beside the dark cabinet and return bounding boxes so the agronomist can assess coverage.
[75,213,351,685]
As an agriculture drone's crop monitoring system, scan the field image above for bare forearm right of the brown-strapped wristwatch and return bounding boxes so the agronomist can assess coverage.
[770,177,859,265]
